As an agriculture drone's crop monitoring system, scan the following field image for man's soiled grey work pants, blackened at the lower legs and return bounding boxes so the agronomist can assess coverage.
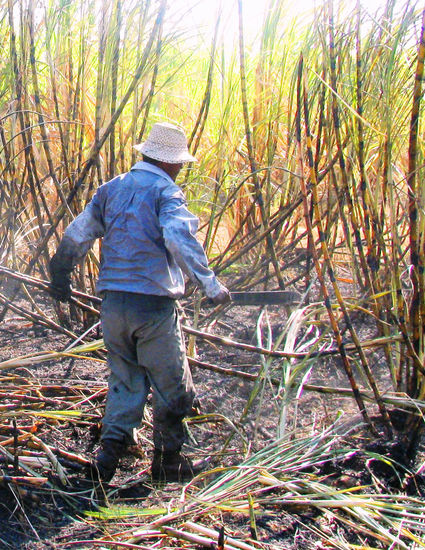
[101,291,194,451]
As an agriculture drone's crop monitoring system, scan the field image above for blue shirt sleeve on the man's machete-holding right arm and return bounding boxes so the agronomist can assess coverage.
[159,190,223,298]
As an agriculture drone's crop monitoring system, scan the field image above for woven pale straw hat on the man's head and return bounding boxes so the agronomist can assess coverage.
[134,122,196,164]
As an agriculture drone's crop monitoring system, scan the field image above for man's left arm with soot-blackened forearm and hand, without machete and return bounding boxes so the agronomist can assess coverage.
[49,194,104,301]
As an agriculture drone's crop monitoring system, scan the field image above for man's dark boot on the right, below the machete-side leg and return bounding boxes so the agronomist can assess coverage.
[151,449,198,483]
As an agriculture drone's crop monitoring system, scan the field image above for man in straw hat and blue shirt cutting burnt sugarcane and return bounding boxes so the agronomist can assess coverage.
[50,123,230,481]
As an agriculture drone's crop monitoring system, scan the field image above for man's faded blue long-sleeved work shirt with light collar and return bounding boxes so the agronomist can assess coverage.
[57,162,222,299]
